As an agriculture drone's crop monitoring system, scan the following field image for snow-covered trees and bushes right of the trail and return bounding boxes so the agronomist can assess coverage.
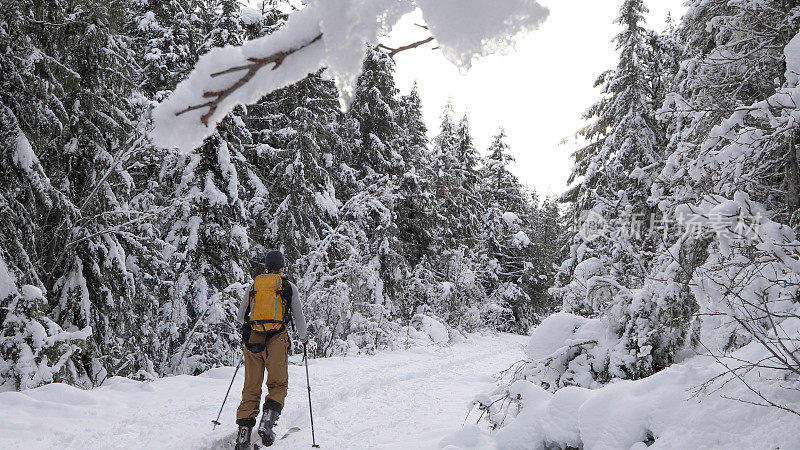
[476,0,800,434]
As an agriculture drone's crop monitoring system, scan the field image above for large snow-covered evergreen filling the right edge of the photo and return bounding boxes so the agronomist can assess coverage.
[653,1,800,358]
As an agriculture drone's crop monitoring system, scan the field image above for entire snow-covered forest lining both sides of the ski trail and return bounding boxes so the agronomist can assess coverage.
[6,0,800,442]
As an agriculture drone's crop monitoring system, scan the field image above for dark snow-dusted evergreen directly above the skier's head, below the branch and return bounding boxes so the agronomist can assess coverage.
[247,74,341,261]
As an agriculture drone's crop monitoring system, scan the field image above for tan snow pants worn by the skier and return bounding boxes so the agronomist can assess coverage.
[236,330,289,420]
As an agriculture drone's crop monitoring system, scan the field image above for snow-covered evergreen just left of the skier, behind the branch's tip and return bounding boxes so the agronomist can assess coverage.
[156,0,252,372]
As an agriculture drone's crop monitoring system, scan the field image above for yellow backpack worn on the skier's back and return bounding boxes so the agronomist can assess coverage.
[247,273,291,334]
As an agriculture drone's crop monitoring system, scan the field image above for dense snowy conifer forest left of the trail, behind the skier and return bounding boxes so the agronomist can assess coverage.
[0,0,561,390]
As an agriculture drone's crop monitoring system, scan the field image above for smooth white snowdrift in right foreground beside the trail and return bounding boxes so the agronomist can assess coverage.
[441,313,800,449]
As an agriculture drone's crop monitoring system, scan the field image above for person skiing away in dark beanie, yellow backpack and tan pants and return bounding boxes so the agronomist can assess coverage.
[236,250,308,450]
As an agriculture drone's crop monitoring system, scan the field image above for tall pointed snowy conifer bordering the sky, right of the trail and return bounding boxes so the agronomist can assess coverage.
[552,0,676,378]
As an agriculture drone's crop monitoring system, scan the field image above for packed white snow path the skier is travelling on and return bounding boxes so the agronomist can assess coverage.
[0,334,526,449]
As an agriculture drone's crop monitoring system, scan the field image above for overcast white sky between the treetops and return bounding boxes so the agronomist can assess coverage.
[388,0,683,196]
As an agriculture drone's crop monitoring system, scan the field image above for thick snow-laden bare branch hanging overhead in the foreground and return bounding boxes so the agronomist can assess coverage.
[151,0,549,152]
